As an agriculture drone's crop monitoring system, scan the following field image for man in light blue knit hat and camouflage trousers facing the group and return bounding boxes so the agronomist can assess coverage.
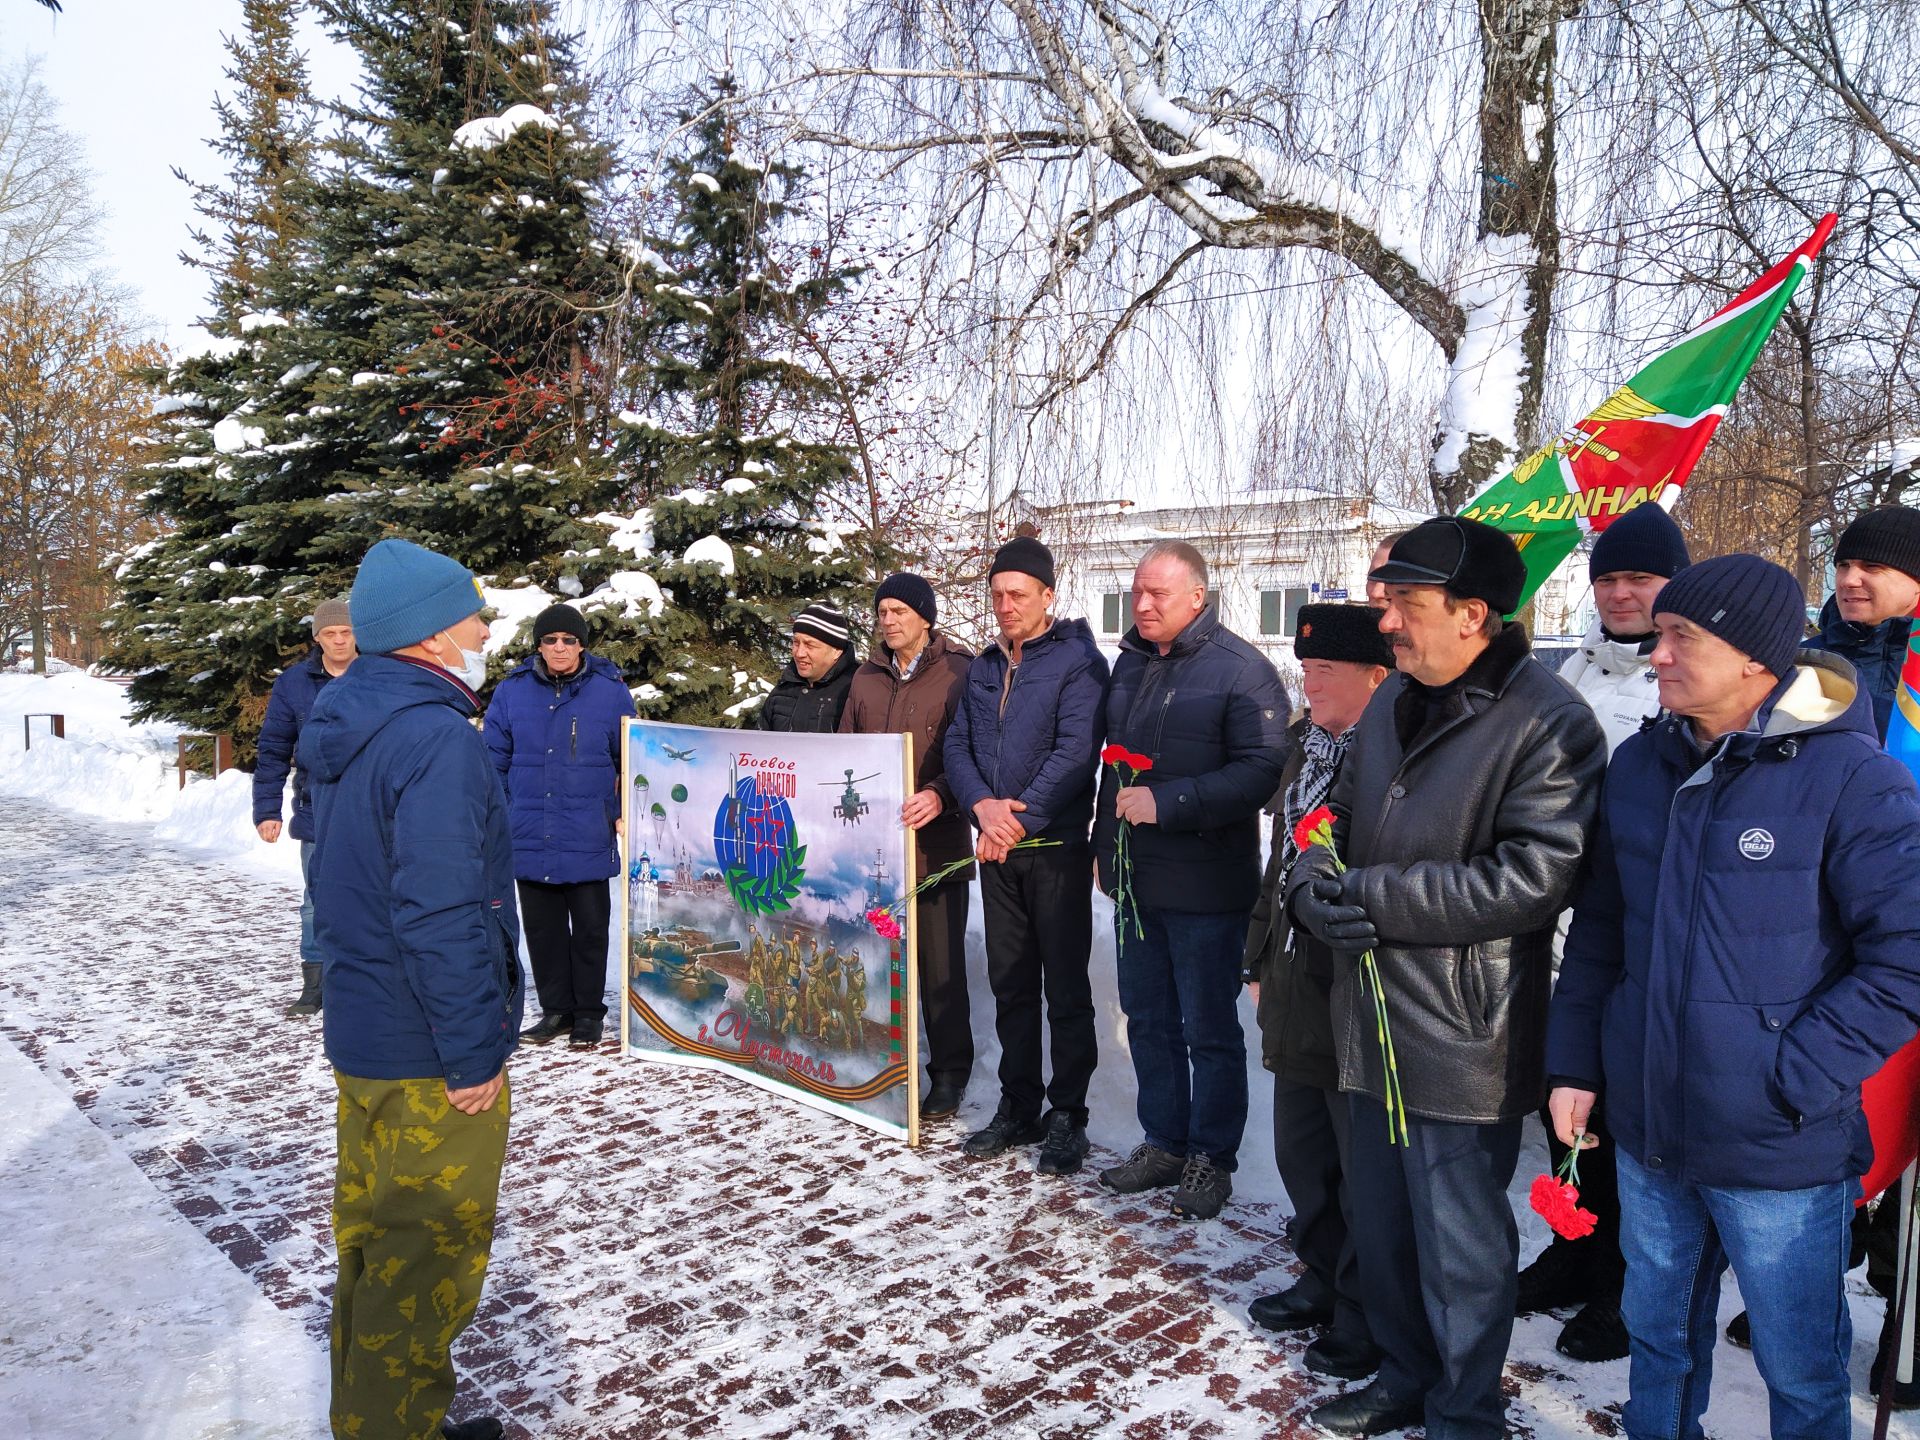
[300,540,520,1440]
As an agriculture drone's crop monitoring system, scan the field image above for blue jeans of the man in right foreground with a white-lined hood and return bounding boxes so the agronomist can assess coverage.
[1617,1150,1860,1440]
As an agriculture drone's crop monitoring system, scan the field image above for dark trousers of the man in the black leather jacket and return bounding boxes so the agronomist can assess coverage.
[1348,1094,1521,1440]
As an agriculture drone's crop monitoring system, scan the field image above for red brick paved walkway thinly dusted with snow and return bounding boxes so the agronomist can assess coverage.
[0,801,1827,1440]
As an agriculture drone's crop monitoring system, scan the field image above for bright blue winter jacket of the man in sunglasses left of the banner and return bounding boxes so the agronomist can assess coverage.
[480,655,634,885]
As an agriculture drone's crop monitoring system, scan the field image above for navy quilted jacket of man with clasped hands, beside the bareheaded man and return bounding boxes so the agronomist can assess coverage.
[947,620,1106,841]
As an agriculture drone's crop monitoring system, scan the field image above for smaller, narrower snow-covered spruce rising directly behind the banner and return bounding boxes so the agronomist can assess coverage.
[584,79,885,724]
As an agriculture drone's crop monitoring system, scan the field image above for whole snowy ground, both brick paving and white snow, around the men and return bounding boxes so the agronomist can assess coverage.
[0,678,1920,1440]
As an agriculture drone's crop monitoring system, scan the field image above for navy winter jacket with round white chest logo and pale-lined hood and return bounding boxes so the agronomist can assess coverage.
[1548,651,1920,1190]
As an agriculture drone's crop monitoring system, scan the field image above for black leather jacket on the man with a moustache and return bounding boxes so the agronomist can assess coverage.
[1286,626,1607,1125]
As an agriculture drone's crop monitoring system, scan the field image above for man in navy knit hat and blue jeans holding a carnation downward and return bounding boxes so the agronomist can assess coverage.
[1548,555,1920,1440]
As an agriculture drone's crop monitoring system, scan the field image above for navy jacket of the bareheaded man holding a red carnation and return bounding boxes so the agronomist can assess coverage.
[1092,605,1290,912]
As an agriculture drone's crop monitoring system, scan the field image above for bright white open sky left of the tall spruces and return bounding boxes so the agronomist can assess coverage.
[0,0,353,348]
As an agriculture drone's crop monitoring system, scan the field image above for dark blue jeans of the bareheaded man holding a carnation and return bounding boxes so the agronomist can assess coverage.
[1117,906,1248,1171]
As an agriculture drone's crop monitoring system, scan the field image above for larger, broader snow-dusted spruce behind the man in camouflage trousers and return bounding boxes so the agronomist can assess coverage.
[107,0,620,739]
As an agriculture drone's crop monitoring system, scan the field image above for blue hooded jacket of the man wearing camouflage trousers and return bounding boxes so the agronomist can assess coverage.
[300,655,520,1089]
